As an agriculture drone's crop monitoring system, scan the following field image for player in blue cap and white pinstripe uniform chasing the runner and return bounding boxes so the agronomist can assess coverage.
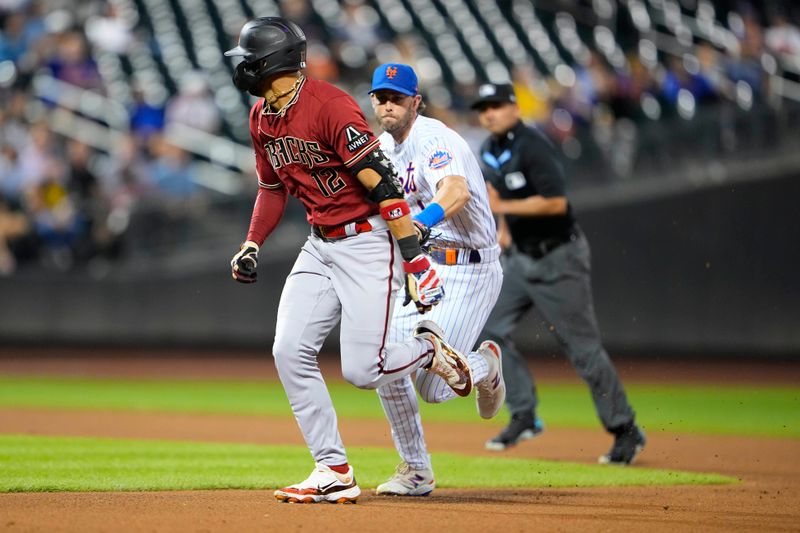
[370,63,505,496]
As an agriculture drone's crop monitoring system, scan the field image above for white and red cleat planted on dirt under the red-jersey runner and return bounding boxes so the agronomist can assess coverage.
[275,463,361,503]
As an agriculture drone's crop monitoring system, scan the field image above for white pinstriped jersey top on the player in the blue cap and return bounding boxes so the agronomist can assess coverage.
[378,116,497,250]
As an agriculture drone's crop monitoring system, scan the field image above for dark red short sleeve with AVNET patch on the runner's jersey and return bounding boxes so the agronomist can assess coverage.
[321,95,380,168]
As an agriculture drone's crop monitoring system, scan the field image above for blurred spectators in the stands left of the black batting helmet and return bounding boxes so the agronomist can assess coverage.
[0,0,220,275]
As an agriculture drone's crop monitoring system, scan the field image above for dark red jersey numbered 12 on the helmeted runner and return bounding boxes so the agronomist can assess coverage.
[250,78,380,226]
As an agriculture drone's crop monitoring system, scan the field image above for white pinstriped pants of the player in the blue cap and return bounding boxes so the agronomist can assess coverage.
[378,260,503,469]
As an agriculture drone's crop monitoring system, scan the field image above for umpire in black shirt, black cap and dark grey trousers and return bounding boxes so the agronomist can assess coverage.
[472,84,645,464]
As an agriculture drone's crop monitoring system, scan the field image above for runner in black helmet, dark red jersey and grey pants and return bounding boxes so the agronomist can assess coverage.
[225,17,472,503]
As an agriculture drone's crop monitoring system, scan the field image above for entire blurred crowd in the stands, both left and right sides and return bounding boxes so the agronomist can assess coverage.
[0,0,800,275]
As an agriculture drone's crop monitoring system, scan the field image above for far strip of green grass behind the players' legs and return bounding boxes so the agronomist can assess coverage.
[0,376,800,438]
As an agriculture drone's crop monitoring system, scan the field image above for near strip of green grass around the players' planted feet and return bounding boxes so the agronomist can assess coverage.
[0,435,735,492]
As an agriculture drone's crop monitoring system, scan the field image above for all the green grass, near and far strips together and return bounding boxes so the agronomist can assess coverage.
[0,376,800,492]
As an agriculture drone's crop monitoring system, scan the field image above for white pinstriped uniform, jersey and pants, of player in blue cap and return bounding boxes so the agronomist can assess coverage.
[378,116,503,469]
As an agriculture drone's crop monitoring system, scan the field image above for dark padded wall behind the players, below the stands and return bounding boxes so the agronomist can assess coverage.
[0,175,800,356]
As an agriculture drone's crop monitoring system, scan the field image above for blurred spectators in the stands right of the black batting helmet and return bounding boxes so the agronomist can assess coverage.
[290,0,800,164]
